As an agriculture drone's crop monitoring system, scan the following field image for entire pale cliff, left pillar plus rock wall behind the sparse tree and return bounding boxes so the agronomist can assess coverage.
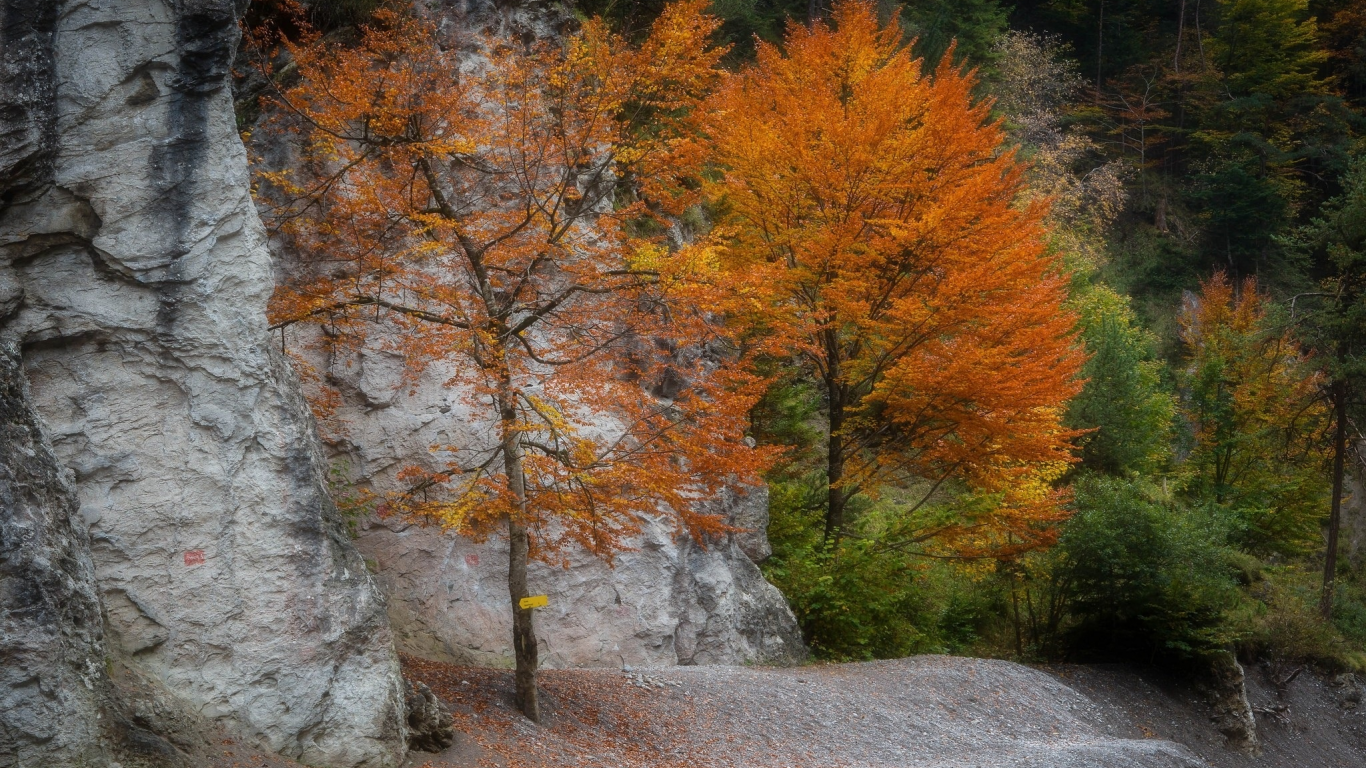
[0,0,803,767]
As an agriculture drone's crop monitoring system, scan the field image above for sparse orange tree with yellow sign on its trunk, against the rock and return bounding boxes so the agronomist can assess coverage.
[257,0,765,720]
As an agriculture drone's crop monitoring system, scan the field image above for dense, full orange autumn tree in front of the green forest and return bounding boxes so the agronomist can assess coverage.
[702,0,1082,555]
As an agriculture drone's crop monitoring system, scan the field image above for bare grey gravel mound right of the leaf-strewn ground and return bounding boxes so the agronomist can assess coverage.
[653,656,1201,768]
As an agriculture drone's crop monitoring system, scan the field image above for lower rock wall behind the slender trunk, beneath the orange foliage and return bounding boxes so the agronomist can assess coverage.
[361,508,805,667]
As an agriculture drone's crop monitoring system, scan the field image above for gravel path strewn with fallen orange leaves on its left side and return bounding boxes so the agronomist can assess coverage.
[406,656,1203,768]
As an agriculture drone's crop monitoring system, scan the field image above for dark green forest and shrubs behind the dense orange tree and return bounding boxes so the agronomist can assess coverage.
[248,0,1366,680]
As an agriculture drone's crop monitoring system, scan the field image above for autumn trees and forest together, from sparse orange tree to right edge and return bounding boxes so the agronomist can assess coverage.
[247,0,1366,719]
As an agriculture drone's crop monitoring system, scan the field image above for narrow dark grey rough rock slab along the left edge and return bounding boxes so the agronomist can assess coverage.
[0,347,108,765]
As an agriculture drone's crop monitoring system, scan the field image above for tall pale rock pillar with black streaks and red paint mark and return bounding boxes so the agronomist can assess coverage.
[0,0,406,767]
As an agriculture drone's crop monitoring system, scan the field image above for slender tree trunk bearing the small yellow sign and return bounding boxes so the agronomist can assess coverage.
[497,368,541,723]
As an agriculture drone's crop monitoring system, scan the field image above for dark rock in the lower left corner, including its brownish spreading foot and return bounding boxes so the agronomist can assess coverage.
[0,344,199,768]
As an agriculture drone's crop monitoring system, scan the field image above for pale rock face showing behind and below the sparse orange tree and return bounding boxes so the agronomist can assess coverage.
[261,3,805,667]
